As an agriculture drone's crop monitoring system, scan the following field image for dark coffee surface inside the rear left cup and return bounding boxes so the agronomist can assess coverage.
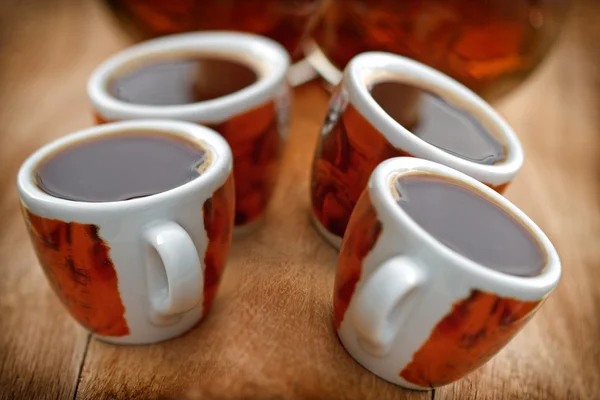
[108,57,257,106]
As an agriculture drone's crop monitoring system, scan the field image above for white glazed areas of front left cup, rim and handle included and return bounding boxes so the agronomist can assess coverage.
[18,120,233,344]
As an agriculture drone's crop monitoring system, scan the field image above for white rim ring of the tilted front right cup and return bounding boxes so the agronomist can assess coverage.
[368,157,561,298]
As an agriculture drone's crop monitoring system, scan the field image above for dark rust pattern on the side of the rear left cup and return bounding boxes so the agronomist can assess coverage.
[94,101,288,225]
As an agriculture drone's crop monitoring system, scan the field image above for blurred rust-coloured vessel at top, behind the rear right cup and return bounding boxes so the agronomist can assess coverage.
[307,0,570,99]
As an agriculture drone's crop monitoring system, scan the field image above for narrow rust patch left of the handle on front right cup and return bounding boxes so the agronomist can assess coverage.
[333,190,381,329]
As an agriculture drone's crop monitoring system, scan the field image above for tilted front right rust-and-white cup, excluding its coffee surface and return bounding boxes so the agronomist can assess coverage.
[334,157,561,390]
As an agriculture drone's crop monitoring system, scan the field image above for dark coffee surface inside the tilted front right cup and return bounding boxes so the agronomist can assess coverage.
[392,174,545,276]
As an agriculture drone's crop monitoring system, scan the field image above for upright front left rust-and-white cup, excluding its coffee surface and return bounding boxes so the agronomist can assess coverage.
[17,120,234,344]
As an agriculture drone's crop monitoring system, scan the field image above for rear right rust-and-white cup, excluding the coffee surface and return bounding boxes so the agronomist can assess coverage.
[311,52,523,248]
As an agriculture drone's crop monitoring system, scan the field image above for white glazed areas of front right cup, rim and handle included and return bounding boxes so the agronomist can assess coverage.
[338,157,561,389]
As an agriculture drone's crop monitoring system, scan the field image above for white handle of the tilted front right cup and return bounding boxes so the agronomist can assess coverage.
[352,256,426,357]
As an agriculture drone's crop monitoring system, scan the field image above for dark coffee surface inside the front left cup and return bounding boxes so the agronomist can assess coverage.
[36,131,210,202]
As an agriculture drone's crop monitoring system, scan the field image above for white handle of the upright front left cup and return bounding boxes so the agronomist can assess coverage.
[142,221,204,325]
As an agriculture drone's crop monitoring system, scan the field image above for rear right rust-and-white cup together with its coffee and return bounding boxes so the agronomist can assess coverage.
[310,53,523,247]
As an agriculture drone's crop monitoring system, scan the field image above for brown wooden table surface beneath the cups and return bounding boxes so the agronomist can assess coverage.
[0,0,600,399]
